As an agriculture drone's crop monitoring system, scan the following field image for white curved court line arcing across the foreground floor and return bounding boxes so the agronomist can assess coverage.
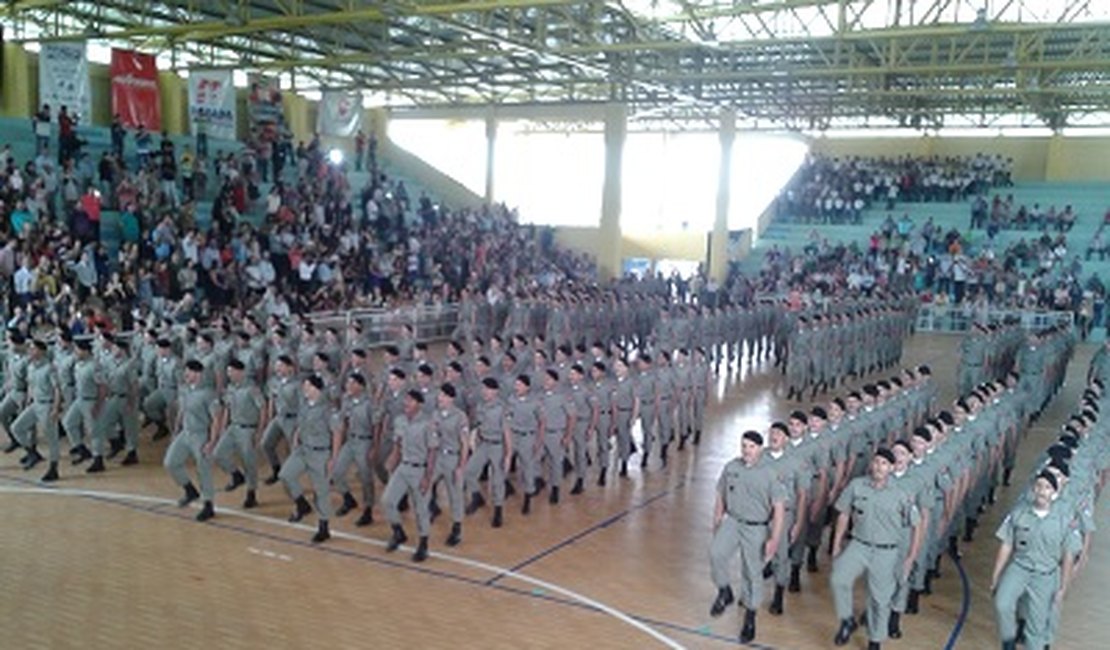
[0,477,685,650]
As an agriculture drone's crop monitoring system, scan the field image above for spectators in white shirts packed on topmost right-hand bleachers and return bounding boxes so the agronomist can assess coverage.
[775,154,1013,223]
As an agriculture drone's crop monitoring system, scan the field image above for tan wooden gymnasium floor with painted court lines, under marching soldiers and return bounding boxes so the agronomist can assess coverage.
[0,335,1110,650]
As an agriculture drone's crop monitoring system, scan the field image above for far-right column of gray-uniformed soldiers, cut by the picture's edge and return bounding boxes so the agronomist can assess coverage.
[991,354,1110,650]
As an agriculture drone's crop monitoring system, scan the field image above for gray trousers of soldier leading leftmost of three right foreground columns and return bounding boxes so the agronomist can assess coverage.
[709,514,768,610]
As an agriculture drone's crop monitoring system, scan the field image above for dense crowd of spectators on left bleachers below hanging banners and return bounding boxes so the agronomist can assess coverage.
[0,107,596,333]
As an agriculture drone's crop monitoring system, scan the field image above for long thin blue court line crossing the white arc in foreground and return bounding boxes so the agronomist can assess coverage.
[0,470,763,650]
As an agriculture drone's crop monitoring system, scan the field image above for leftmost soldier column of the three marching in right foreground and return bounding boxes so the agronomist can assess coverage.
[709,366,936,642]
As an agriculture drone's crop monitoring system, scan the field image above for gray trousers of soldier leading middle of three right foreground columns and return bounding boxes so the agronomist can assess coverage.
[829,539,901,642]
